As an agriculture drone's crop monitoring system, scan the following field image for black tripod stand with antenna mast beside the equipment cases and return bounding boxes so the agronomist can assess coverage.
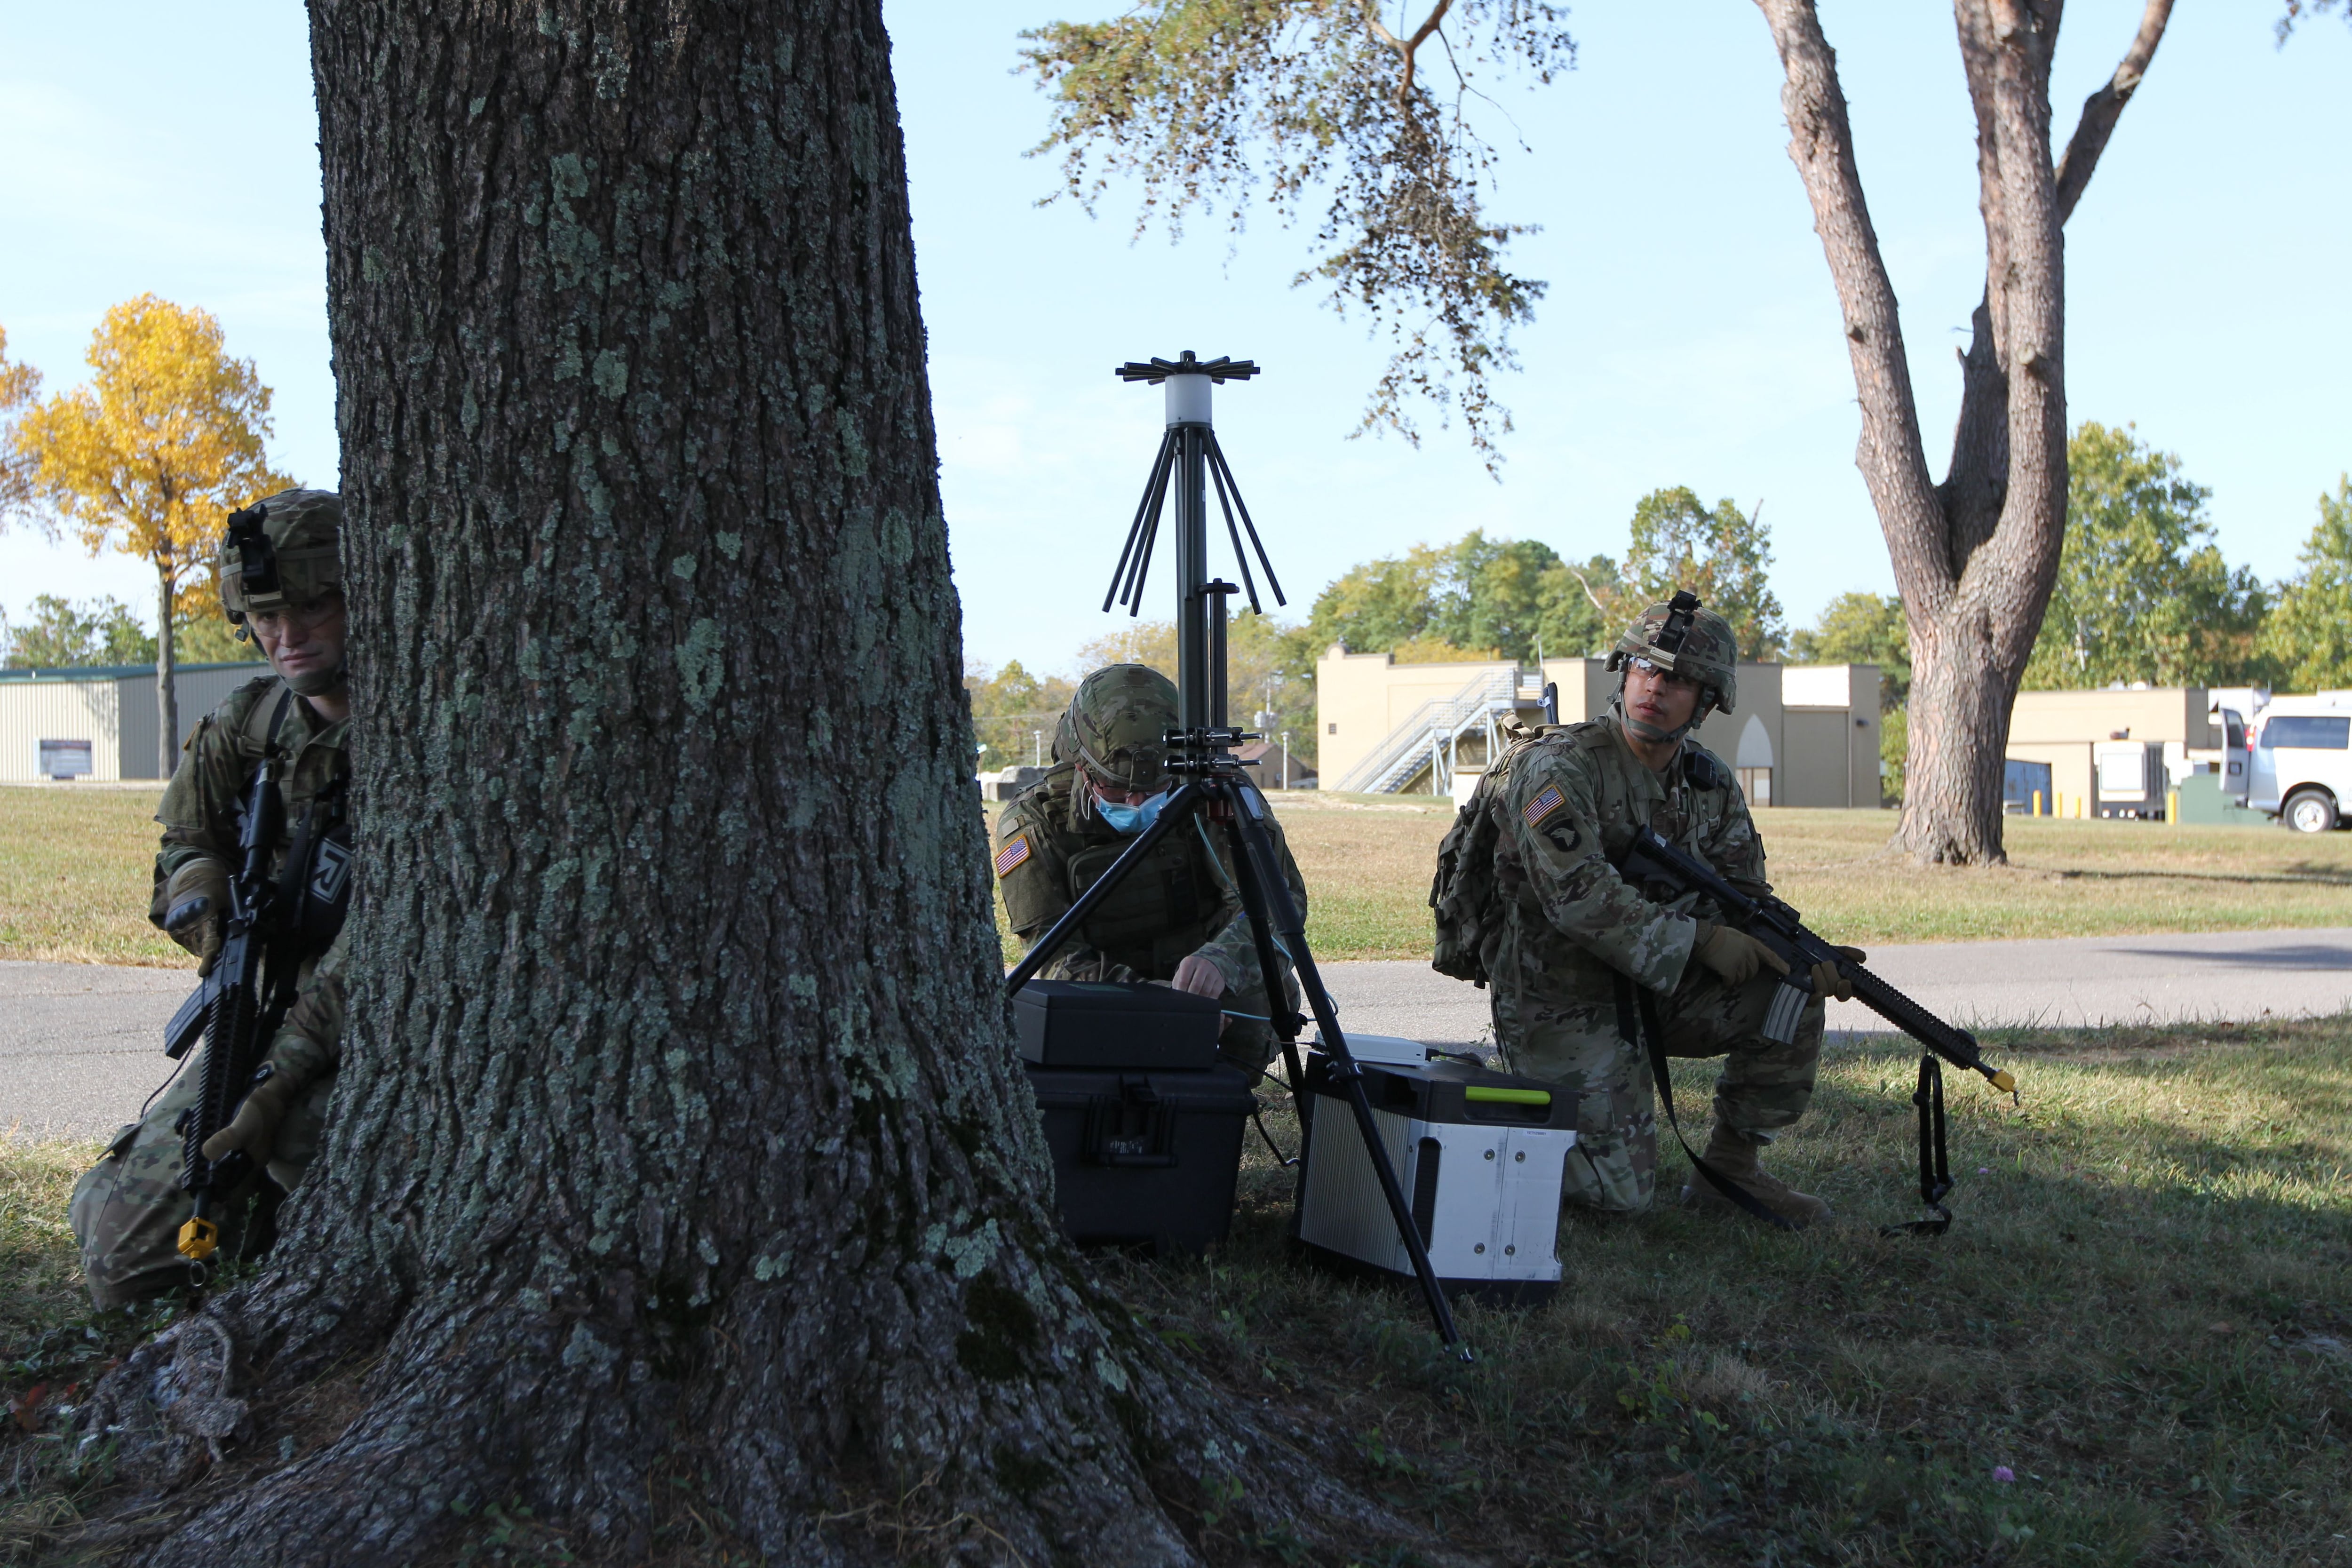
[1007,348,1470,1361]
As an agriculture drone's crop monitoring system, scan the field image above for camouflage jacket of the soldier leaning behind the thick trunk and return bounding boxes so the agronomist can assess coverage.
[148,675,350,973]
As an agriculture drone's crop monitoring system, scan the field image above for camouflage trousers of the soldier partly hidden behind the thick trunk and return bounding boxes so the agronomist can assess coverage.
[68,1051,334,1309]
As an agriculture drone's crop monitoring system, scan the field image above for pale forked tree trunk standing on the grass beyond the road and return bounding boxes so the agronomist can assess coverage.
[1757,0,2171,863]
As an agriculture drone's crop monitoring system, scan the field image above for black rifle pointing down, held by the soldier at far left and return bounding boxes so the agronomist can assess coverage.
[165,759,287,1262]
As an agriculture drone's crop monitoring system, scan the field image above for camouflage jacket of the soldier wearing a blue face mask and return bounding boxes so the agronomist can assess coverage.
[995,762,1308,992]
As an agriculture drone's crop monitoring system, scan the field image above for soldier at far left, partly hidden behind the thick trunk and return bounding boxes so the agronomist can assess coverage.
[71,489,350,1307]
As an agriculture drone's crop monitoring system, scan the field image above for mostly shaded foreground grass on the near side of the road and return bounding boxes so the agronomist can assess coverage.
[0,1018,2352,1568]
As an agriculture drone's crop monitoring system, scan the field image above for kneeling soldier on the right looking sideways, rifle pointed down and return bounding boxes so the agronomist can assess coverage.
[1486,602,1860,1225]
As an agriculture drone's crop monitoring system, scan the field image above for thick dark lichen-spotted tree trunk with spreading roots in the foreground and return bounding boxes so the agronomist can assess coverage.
[83,0,1395,1563]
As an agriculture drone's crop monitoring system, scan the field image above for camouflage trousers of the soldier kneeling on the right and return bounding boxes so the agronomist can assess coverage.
[1494,962,1823,1213]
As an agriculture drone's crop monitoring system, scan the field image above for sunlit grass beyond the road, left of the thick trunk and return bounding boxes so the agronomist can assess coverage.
[0,785,195,969]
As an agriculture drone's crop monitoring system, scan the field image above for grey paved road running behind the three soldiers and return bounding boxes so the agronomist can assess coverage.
[0,926,2352,1138]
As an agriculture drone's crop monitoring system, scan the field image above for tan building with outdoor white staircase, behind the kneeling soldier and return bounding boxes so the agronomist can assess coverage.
[1315,644,1879,806]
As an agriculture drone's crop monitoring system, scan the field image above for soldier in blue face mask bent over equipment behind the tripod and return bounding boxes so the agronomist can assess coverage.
[995,665,1308,1070]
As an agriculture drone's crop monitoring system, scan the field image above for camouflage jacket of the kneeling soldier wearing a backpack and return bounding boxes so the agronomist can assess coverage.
[1491,717,1766,1004]
